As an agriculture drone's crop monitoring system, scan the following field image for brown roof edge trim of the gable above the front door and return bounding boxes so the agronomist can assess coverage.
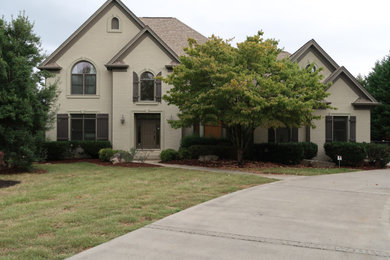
[106,26,179,69]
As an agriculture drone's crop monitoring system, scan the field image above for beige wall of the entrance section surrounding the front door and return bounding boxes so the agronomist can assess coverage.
[112,37,182,150]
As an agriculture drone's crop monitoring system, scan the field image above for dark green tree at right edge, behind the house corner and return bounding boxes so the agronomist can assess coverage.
[364,55,390,141]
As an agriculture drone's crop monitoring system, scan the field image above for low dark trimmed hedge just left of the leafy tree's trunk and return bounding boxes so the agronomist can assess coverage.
[188,145,237,160]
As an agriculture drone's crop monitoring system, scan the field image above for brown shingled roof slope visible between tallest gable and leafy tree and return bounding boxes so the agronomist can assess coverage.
[140,17,207,56]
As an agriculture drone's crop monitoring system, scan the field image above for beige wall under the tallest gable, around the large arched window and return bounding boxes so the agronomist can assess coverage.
[46,6,139,140]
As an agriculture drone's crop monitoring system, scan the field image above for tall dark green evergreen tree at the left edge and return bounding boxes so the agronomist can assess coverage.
[0,14,56,169]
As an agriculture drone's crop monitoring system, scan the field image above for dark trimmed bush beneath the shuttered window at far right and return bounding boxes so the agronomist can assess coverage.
[324,142,366,166]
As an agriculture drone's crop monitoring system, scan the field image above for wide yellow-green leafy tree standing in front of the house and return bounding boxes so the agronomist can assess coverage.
[164,32,327,163]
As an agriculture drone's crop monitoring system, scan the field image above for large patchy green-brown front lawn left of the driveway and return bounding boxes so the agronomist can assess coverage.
[0,163,273,259]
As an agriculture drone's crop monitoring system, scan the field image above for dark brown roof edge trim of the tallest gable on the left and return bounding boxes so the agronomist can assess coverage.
[38,0,145,70]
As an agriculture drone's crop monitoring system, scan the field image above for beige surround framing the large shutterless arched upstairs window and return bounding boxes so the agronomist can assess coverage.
[65,57,101,99]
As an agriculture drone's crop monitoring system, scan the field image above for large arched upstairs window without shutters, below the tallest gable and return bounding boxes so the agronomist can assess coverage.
[71,61,96,95]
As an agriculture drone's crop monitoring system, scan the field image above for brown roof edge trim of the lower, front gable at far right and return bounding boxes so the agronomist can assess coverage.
[324,66,379,106]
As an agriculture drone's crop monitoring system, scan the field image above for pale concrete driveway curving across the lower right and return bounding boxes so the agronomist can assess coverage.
[71,170,390,259]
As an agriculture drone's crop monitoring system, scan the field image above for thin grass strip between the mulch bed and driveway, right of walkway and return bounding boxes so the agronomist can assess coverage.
[255,167,358,176]
